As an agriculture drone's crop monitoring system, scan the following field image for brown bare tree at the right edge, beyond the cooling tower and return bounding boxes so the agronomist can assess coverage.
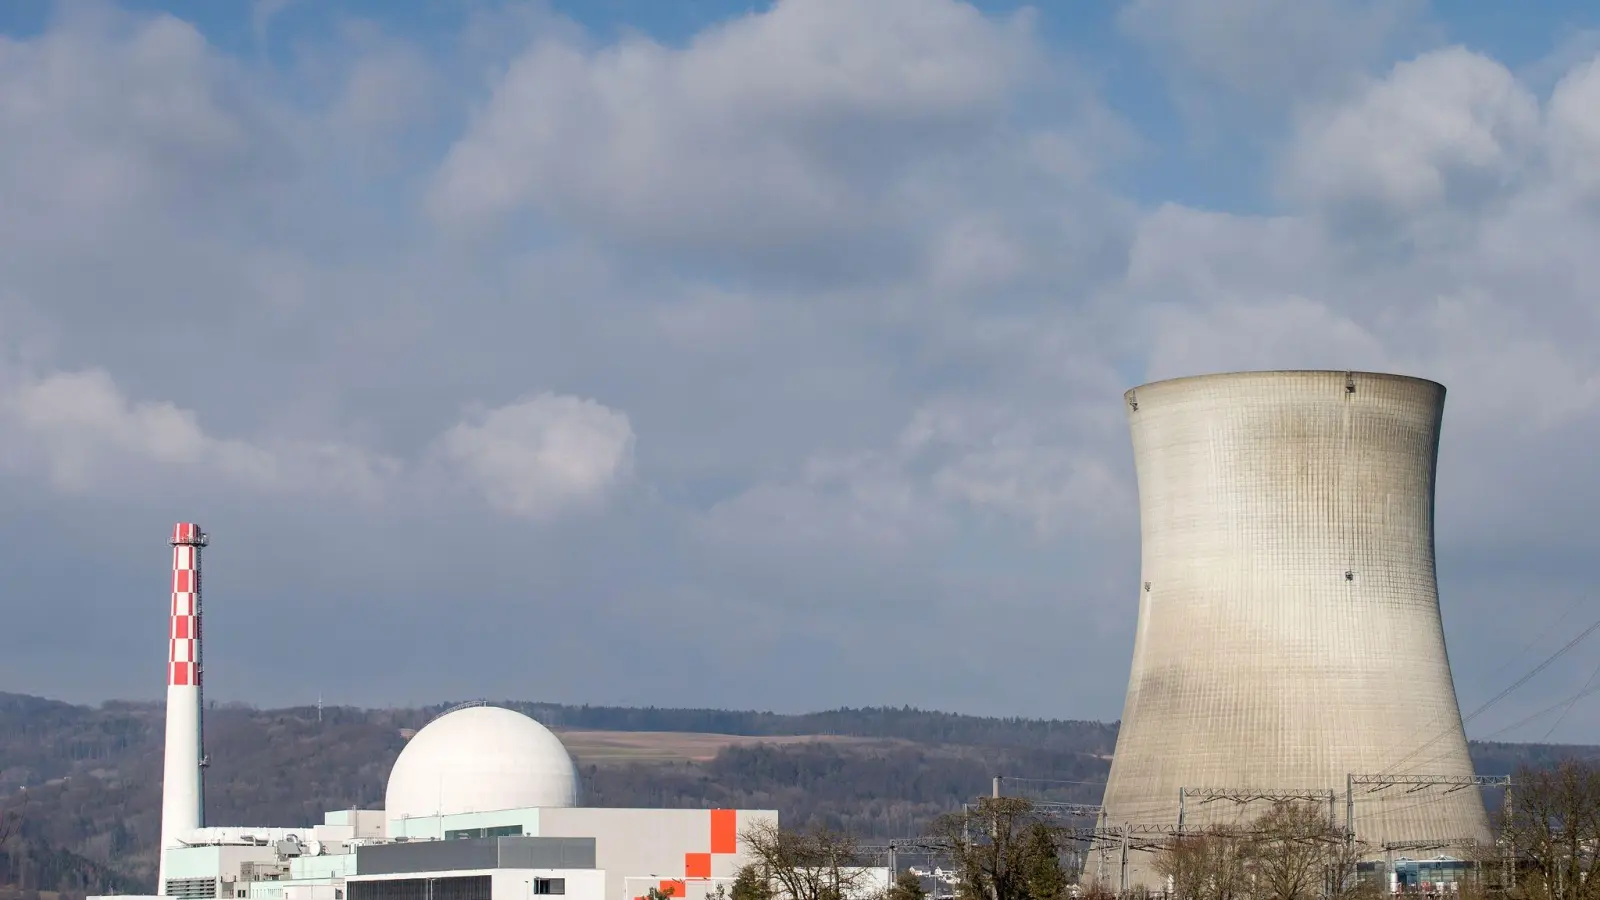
[1502,759,1600,900]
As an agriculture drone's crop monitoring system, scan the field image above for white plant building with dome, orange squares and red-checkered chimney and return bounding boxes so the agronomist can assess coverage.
[95,522,778,900]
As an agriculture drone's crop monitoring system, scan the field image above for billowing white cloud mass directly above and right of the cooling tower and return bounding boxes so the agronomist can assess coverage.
[1114,48,1600,566]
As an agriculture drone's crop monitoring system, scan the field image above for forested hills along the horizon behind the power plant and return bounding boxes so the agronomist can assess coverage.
[0,693,1600,892]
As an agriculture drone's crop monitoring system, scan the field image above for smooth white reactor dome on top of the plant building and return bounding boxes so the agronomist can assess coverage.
[384,706,578,820]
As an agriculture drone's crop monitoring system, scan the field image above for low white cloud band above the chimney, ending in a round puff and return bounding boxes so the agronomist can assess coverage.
[0,347,634,519]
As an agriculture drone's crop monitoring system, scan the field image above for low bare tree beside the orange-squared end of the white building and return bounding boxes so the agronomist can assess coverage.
[744,822,870,900]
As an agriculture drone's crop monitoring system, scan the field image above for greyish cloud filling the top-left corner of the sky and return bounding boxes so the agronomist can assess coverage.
[0,5,285,229]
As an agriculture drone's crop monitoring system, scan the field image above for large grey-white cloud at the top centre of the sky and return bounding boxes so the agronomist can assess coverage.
[432,0,1037,262]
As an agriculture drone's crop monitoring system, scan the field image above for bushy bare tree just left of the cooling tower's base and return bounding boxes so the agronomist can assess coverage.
[928,798,1066,900]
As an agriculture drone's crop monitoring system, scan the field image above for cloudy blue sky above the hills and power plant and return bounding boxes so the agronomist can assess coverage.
[0,0,1600,741]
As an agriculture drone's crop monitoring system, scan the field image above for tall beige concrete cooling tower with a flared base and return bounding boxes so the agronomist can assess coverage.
[1086,372,1488,889]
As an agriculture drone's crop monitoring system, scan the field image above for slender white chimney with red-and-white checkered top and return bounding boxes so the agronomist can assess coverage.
[155,522,210,897]
